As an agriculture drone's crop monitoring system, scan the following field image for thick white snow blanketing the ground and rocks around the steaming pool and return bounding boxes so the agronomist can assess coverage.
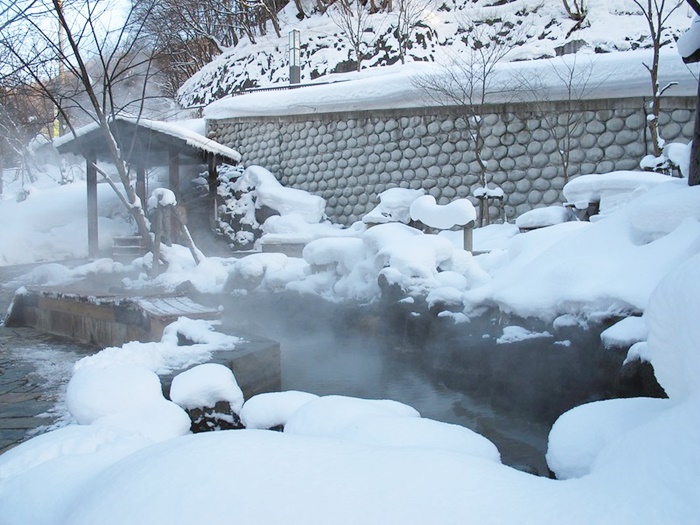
[0,152,700,524]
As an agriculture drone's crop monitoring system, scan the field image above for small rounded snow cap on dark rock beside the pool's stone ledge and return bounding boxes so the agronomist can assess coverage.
[170,363,243,414]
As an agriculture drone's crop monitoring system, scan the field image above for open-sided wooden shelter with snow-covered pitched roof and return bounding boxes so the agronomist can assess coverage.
[54,117,241,257]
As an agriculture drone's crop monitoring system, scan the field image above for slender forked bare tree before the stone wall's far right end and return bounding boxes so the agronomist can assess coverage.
[632,0,683,157]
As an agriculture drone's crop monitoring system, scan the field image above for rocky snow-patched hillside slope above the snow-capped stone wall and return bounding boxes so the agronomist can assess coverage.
[178,0,692,107]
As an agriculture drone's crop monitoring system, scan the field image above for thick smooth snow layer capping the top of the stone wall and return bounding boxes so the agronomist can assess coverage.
[204,48,697,119]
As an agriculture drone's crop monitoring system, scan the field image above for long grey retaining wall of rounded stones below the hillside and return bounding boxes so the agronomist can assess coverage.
[207,97,695,224]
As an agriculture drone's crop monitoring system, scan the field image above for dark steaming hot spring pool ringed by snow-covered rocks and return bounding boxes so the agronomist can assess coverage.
[210,294,660,475]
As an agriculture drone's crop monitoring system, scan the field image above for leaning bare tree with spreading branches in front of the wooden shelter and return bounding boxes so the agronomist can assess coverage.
[0,0,158,251]
